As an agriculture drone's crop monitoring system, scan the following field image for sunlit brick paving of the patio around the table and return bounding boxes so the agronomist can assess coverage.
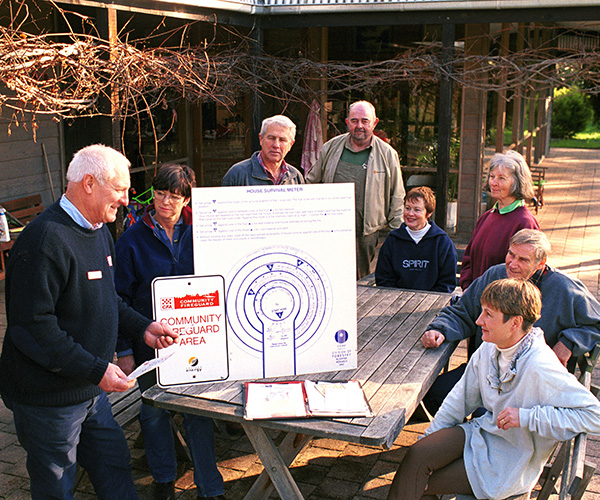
[0,149,600,500]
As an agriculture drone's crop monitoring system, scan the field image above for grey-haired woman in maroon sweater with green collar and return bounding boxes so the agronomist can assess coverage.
[460,150,540,290]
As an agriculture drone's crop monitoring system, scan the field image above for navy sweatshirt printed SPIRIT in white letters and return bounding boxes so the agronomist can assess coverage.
[375,222,456,292]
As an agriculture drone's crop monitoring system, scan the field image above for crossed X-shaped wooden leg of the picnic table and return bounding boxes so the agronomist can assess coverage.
[242,422,312,500]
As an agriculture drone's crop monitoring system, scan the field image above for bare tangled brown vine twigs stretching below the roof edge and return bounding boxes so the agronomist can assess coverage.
[0,8,600,130]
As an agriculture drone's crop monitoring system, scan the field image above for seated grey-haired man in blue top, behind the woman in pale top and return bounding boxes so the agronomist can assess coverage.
[421,229,600,414]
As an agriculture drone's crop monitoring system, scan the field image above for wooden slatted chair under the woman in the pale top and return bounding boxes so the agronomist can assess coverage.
[537,344,600,500]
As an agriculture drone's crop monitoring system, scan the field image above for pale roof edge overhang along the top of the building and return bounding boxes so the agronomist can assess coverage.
[52,0,600,28]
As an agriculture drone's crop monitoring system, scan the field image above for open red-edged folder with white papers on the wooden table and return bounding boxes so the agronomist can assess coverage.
[244,380,372,420]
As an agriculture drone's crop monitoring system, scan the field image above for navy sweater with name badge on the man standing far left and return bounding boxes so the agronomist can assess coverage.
[0,202,151,406]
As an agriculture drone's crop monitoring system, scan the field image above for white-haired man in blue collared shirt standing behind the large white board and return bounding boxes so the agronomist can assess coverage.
[222,115,304,186]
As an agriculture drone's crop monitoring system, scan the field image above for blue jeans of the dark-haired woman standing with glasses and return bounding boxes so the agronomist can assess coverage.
[140,404,224,497]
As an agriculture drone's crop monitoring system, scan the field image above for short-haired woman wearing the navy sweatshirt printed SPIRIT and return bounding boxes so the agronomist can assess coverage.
[375,186,456,292]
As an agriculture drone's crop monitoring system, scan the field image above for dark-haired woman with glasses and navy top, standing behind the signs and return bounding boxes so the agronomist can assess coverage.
[115,164,224,500]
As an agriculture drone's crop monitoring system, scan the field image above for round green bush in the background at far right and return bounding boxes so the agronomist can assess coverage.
[552,88,594,138]
